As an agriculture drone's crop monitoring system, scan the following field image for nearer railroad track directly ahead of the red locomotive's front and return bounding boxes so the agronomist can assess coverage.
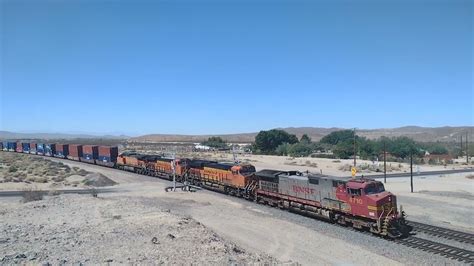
[396,236,474,264]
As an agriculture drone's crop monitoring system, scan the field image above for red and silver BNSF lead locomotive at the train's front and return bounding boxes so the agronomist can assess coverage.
[255,170,411,238]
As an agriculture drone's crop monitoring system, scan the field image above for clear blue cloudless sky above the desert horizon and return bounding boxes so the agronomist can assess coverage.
[0,0,474,134]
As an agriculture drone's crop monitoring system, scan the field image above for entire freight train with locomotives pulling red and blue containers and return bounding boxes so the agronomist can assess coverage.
[0,141,412,238]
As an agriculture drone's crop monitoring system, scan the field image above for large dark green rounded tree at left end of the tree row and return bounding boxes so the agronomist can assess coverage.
[254,129,298,154]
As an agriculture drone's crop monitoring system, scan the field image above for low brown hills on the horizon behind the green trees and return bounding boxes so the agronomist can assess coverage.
[129,126,474,143]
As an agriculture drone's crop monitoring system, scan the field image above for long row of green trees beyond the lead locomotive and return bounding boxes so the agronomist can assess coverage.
[252,129,466,160]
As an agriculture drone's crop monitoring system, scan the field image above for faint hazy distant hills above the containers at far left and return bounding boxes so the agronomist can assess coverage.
[0,131,130,140]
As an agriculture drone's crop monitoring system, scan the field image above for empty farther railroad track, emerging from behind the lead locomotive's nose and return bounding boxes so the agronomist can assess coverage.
[408,221,474,245]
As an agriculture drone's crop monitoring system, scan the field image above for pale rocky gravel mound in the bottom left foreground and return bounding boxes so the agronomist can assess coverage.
[0,195,278,265]
